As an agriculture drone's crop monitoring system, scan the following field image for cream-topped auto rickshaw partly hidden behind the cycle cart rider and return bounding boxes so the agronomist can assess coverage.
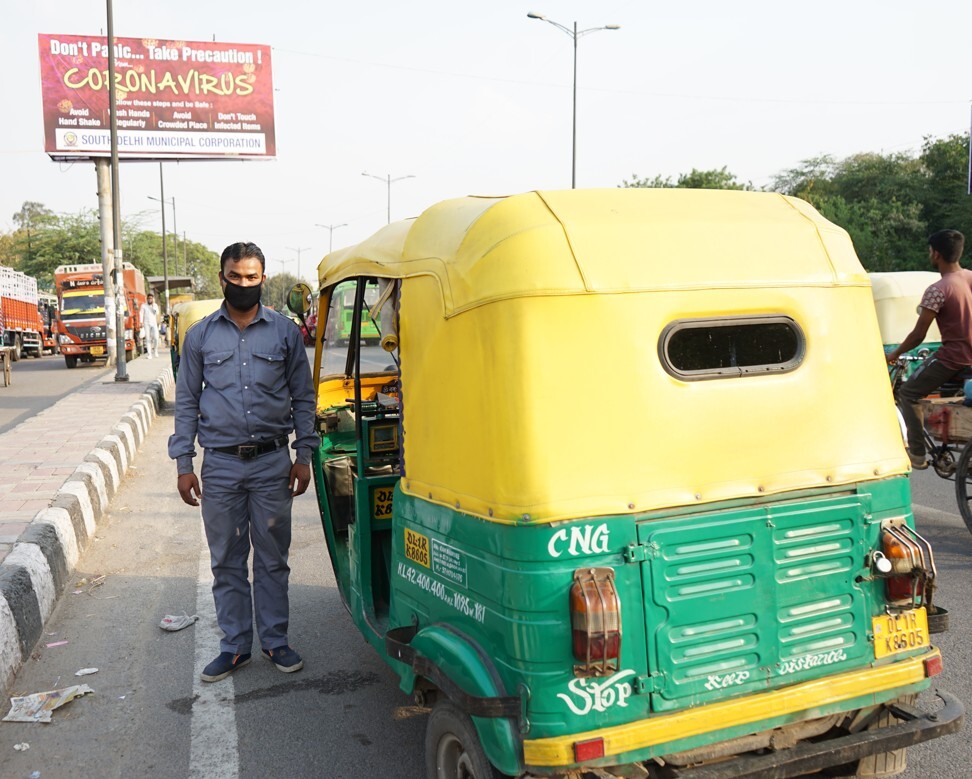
[868,270,942,379]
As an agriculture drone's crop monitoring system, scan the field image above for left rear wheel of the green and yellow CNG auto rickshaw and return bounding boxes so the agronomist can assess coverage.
[425,696,503,779]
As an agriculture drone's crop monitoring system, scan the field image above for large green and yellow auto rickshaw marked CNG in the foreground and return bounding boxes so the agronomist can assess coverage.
[291,189,964,779]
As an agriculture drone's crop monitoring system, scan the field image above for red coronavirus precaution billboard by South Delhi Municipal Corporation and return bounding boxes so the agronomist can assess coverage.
[37,34,277,160]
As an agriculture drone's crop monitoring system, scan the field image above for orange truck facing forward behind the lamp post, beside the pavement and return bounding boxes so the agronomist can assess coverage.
[54,262,145,368]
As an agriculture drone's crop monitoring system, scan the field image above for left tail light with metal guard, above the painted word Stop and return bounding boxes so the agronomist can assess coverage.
[570,568,621,676]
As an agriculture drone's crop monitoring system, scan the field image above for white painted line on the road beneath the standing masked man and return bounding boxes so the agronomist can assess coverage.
[189,519,240,779]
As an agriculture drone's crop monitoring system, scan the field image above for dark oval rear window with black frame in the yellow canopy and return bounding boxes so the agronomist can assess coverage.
[658,316,806,380]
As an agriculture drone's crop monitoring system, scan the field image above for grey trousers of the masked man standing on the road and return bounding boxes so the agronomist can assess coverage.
[201,447,293,655]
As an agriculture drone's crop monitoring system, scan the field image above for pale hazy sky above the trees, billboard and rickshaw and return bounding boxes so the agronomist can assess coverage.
[0,0,972,280]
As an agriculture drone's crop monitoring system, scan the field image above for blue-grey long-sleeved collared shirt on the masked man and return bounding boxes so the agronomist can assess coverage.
[169,303,320,475]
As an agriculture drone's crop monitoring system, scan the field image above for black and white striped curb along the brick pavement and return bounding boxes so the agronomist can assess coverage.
[0,370,173,689]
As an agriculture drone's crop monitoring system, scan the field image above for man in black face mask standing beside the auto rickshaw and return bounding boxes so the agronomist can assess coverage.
[169,243,319,682]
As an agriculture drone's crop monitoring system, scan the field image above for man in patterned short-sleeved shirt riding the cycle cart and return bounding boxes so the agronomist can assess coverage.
[888,230,972,470]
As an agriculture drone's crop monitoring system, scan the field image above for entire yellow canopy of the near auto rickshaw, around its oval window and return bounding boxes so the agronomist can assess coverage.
[318,189,908,523]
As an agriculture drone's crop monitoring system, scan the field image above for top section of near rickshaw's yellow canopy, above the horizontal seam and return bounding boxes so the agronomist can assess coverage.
[319,189,868,317]
